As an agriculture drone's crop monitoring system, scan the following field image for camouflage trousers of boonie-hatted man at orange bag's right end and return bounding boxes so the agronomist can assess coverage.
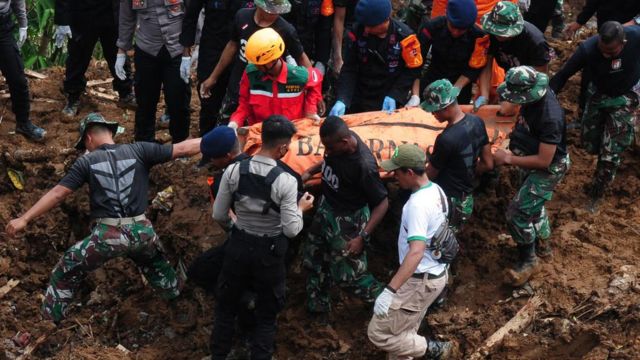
[507,155,571,245]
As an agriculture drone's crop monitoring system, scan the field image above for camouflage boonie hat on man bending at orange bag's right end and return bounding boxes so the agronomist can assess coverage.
[497,66,549,104]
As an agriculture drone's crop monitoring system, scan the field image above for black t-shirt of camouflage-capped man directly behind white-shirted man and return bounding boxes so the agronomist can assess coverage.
[430,114,489,198]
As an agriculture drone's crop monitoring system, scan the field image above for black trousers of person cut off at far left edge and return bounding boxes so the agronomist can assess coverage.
[0,16,30,124]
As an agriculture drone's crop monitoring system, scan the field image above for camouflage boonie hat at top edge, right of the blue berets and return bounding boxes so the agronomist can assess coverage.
[482,1,524,37]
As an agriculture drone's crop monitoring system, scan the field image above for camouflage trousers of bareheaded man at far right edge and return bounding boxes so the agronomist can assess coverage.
[582,85,638,193]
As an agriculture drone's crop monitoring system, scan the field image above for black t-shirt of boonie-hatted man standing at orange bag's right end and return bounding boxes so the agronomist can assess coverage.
[516,89,567,162]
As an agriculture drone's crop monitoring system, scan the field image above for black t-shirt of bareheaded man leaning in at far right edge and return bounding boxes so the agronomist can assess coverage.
[550,25,640,97]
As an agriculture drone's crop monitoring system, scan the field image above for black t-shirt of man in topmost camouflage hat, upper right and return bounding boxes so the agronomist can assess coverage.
[489,21,551,70]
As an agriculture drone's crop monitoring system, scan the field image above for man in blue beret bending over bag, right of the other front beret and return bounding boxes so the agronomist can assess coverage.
[416,0,488,106]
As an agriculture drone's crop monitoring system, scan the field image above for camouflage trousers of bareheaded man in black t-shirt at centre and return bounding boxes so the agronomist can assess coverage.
[303,199,384,312]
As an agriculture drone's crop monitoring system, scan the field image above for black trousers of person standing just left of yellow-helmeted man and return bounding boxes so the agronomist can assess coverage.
[197,53,231,136]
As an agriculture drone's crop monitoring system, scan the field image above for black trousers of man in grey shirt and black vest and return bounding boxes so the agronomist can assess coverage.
[211,229,288,360]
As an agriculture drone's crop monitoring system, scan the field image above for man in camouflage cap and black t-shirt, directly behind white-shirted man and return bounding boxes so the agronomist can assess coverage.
[422,79,493,233]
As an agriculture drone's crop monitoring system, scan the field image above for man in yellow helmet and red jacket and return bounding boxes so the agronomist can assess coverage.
[229,28,322,129]
